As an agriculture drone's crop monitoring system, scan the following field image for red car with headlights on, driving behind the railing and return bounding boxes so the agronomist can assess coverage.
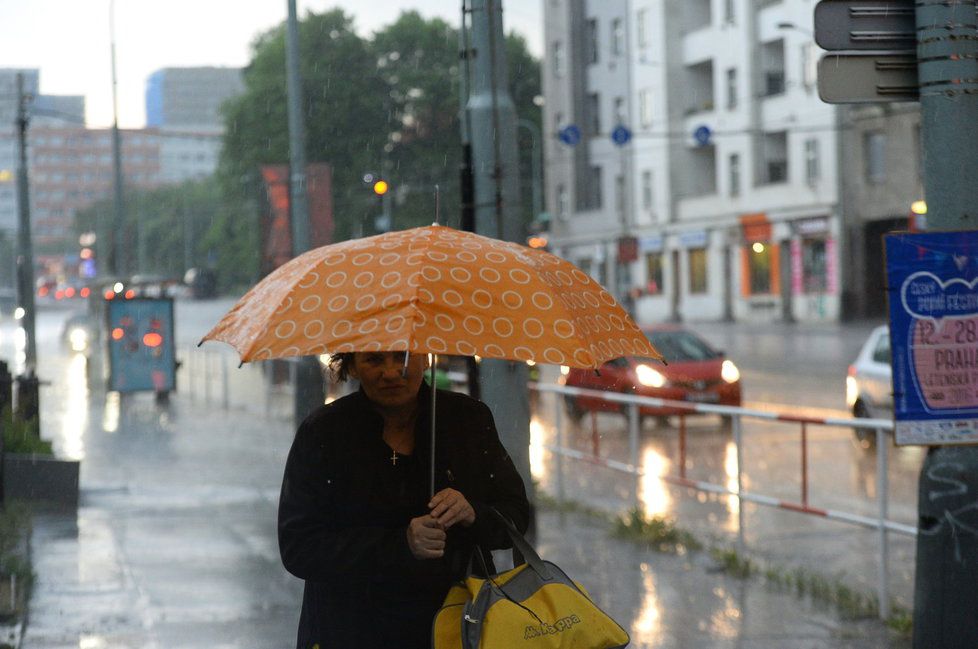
[561,325,741,426]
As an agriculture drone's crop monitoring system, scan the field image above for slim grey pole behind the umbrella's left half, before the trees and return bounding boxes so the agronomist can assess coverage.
[285,0,324,425]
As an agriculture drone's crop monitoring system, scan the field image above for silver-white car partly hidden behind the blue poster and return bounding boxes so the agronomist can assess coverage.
[846,325,893,443]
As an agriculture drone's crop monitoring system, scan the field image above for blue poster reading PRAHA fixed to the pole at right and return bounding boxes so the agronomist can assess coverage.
[885,231,978,445]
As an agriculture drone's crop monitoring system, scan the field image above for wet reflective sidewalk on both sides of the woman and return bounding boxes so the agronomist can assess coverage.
[21,380,909,649]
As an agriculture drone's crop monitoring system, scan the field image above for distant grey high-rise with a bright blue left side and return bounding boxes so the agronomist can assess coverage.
[146,67,244,132]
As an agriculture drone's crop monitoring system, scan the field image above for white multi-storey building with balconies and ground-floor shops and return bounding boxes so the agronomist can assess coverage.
[543,0,841,323]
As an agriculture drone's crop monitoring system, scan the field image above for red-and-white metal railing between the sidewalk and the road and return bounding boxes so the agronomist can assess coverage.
[530,383,917,620]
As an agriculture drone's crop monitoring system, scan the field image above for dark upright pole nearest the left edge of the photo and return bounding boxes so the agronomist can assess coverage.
[17,72,37,376]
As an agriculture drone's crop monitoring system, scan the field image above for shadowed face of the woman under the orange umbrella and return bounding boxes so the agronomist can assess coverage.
[350,352,428,408]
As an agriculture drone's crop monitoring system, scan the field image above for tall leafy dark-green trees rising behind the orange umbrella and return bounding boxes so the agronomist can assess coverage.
[207,9,540,286]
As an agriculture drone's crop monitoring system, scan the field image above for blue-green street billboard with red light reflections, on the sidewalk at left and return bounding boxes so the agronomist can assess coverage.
[107,296,176,392]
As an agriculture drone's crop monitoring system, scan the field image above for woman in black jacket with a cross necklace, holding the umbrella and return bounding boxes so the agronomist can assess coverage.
[279,352,529,649]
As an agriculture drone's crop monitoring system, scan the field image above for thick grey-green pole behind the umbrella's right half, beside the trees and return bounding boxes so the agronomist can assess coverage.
[462,0,535,535]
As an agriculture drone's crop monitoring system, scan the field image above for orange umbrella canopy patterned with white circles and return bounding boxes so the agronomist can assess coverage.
[201,225,661,368]
